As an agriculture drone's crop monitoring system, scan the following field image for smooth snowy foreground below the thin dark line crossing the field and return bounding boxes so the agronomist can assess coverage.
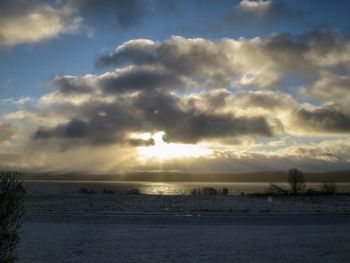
[18,214,350,263]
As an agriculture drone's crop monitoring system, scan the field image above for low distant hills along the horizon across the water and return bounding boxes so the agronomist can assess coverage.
[15,171,350,182]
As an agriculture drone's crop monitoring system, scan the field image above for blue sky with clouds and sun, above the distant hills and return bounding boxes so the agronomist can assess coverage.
[0,0,350,173]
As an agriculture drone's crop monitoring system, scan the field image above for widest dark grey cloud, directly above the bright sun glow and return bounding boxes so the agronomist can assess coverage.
[34,90,273,144]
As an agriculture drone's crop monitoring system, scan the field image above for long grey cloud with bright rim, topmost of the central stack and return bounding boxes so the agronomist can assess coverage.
[97,37,229,78]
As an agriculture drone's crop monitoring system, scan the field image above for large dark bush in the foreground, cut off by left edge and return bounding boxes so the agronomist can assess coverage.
[0,172,24,263]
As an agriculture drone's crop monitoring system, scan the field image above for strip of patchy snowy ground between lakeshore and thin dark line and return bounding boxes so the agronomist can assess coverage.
[25,194,350,216]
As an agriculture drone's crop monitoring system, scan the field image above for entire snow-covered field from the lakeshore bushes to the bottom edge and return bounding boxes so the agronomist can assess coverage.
[18,195,350,263]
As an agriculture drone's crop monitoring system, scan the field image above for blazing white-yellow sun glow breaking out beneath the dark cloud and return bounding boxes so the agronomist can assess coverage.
[132,132,212,160]
